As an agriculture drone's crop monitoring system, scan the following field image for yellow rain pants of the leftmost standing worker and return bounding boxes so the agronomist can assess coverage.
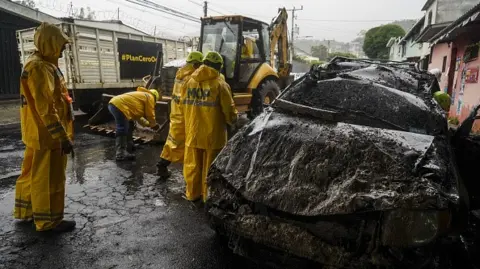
[14,147,67,231]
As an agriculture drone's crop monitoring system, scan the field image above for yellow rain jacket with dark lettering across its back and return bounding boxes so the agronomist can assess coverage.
[181,65,237,149]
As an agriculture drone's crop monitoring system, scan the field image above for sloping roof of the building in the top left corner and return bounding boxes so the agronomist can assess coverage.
[0,0,61,23]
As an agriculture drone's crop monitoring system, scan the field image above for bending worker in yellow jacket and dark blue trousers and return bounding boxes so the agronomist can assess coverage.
[108,87,161,161]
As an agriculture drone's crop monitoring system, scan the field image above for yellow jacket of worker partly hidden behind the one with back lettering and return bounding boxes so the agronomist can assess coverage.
[160,63,195,162]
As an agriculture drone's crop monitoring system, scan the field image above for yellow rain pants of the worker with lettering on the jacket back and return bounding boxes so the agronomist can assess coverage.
[183,147,221,202]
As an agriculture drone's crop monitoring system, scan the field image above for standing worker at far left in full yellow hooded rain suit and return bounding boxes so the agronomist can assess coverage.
[14,23,75,232]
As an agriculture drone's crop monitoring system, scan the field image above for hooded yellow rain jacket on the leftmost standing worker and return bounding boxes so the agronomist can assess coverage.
[20,24,73,150]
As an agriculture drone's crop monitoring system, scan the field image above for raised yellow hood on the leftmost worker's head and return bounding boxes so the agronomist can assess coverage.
[34,22,68,63]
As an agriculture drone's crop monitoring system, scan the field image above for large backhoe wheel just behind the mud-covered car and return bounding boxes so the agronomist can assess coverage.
[248,80,280,119]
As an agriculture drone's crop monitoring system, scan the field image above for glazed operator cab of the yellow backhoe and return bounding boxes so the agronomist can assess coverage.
[199,16,270,92]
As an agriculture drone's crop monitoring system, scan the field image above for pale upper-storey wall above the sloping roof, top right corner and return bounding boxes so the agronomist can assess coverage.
[435,0,480,23]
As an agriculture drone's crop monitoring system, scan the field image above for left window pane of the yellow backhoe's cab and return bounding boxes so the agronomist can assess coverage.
[202,21,238,78]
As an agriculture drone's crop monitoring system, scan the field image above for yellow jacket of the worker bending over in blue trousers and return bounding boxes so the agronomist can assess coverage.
[110,87,158,127]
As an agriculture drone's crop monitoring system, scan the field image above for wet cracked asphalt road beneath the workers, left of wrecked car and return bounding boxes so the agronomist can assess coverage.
[0,118,263,269]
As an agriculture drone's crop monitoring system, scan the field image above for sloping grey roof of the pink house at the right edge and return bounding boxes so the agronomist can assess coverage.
[429,3,480,44]
